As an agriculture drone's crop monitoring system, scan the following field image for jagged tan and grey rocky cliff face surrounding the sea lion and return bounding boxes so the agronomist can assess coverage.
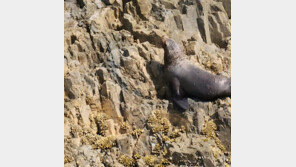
[64,0,231,167]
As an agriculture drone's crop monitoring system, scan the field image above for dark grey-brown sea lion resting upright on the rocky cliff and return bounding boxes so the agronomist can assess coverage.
[162,37,231,110]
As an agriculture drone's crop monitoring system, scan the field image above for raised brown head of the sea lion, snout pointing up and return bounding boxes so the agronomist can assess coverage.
[162,37,183,65]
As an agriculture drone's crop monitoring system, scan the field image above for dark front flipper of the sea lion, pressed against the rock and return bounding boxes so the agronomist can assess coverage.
[171,78,189,110]
